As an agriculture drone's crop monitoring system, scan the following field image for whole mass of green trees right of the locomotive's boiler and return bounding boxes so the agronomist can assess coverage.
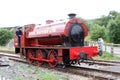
[87,11,120,44]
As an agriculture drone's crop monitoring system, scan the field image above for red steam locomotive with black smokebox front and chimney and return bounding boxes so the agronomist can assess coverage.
[14,14,98,67]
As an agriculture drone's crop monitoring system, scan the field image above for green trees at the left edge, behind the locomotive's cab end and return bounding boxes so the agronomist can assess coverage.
[0,29,15,46]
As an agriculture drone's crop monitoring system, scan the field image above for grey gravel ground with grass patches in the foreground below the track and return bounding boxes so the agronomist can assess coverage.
[0,56,92,80]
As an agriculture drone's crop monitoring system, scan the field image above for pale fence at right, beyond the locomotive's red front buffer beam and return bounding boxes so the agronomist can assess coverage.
[85,41,120,55]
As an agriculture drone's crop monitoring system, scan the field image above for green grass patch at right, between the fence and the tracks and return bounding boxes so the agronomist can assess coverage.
[94,51,120,60]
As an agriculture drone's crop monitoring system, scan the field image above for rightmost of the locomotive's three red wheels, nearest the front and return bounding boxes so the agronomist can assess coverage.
[48,50,58,67]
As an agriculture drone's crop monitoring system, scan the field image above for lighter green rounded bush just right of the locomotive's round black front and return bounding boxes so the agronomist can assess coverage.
[90,24,105,40]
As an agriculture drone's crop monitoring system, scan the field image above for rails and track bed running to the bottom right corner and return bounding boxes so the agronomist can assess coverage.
[72,66,120,80]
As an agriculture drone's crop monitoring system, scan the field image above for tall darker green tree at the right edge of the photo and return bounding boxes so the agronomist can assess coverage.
[106,14,120,44]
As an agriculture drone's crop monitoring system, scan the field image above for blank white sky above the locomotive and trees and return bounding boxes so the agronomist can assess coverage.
[0,0,120,27]
